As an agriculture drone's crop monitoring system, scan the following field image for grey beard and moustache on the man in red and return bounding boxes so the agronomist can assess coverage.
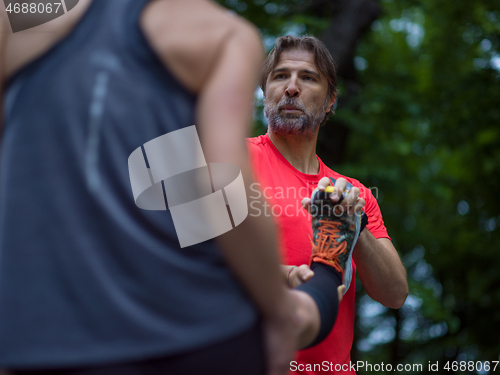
[264,98,328,136]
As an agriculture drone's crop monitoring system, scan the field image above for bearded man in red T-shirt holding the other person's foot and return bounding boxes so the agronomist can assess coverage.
[248,36,408,374]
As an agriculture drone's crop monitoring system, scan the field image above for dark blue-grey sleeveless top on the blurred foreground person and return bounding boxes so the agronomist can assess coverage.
[0,0,257,369]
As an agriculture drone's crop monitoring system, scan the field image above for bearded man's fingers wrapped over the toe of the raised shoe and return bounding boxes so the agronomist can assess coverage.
[302,177,366,215]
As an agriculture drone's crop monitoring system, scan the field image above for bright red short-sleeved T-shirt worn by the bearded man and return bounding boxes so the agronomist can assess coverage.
[248,134,389,375]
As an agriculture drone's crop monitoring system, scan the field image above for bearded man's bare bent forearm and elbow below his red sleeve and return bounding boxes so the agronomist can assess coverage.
[353,229,408,309]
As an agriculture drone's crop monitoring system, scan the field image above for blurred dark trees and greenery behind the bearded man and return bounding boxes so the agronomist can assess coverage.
[219,0,500,374]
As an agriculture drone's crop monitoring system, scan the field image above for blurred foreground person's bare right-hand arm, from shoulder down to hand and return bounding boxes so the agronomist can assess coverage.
[142,0,298,375]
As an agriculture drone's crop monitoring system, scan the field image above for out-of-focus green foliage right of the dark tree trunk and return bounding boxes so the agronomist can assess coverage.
[346,1,500,363]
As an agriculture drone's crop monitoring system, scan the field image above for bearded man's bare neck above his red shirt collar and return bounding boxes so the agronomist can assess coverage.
[267,128,319,174]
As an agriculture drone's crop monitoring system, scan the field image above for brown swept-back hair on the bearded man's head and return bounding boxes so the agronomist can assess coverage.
[260,35,337,113]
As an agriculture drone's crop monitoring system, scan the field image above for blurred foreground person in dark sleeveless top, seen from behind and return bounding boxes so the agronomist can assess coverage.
[0,0,340,375]
